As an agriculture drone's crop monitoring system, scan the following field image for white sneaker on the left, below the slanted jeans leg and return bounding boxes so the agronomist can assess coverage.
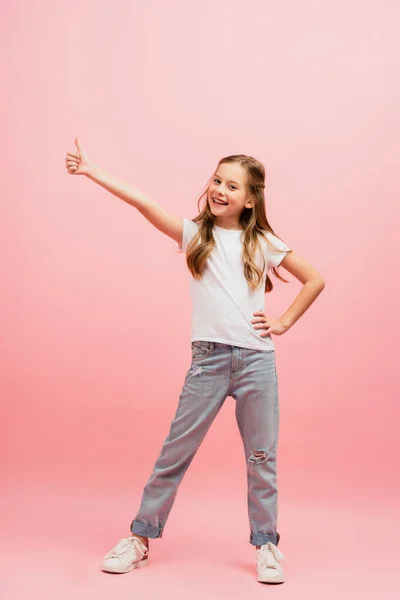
[101,535,149,573]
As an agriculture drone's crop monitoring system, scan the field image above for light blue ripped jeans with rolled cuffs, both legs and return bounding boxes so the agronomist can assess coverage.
[131,341,280,546]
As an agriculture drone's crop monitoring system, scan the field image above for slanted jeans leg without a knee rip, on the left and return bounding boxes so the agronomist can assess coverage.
[131,342,230,538]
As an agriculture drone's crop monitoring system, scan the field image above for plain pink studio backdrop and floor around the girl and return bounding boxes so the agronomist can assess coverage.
[0,0,400,599]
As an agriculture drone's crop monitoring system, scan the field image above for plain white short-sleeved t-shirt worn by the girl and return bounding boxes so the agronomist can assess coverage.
[178,217,290,350]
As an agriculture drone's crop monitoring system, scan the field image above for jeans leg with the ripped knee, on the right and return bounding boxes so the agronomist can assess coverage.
[229,348,279,546]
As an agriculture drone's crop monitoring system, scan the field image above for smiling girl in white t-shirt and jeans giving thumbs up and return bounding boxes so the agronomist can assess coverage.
[66,138,325,583]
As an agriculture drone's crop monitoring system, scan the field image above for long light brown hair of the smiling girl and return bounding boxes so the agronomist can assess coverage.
[186,154,291,293]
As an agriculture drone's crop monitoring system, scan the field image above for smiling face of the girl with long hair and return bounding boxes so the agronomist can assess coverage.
[208,163,252,225]
